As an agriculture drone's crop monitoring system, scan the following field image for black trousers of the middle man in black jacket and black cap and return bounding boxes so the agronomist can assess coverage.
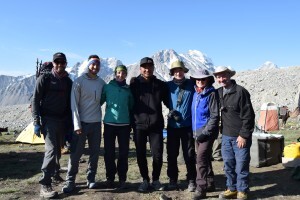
[135,130,163,181]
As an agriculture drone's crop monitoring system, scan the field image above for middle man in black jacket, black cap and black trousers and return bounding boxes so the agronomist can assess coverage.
[130,57,168,192]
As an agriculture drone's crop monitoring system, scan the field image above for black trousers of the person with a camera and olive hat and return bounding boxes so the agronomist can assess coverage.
[167,127,196,181]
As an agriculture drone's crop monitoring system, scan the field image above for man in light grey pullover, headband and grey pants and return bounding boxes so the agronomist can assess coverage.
[62,55,105,193]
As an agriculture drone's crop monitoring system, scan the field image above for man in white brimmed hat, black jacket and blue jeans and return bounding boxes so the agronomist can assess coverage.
[214,66,255,199]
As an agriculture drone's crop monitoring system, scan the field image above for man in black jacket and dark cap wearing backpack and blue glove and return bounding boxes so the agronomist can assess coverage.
[32,52,72,198]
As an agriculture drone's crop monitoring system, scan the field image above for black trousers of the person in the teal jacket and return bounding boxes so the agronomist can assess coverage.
[104,124,131,181]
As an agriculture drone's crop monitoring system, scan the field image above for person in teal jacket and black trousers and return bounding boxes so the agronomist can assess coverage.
[101,65,133,189]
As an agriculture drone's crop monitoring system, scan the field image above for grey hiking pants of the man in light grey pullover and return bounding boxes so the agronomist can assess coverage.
[66,122,101,182]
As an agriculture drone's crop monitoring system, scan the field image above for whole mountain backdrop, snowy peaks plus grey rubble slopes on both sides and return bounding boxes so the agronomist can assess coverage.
[0,50,300,130]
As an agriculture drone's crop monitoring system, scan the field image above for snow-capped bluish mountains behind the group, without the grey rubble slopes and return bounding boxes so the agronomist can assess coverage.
[0,49,214,106]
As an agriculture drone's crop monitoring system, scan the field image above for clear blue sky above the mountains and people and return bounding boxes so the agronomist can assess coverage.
[0,0,300,75]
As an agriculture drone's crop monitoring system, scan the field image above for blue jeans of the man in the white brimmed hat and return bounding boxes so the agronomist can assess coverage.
[222,135,252,192]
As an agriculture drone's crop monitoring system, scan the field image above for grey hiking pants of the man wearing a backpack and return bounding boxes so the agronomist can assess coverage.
[39,118,66,185]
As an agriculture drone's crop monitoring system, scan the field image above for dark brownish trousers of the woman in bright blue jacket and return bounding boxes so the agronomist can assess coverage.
[196,138,214,191]
